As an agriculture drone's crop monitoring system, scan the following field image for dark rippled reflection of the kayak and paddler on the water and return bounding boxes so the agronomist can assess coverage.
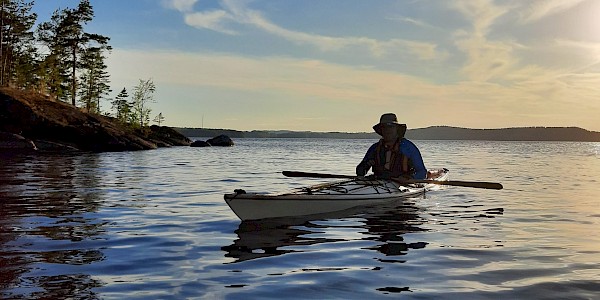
[221,203,427,262]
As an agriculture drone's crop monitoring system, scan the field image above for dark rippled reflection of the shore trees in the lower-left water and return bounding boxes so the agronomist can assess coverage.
[0,154,106,299]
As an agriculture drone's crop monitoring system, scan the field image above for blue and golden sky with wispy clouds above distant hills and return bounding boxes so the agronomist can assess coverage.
[34,0,600,132]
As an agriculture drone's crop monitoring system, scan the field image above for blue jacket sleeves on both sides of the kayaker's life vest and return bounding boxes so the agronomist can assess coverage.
[356,138,427,179]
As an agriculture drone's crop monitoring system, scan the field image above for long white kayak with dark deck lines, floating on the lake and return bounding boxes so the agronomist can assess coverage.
[224,169,448,221]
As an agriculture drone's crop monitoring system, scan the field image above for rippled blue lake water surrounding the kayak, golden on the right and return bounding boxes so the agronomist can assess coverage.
[0,139,600,299]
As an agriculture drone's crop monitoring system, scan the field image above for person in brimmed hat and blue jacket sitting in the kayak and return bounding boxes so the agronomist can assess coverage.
[356,113,427,179]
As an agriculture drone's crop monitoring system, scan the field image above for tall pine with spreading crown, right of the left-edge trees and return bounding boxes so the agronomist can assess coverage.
[37,0,110,106]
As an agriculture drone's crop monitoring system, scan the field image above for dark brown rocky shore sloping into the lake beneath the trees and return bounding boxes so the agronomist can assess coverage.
[0,88,191,152]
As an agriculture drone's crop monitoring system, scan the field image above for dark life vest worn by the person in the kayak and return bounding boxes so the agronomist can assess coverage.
[373,139,412,178]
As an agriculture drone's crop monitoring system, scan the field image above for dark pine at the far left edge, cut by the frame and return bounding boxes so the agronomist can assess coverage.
[0,0,37,86]
